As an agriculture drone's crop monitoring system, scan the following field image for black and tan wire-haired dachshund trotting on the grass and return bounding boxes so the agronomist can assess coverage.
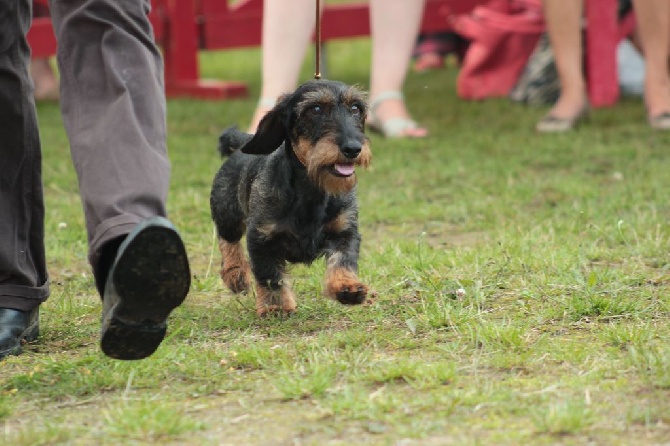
[210,80,371,315]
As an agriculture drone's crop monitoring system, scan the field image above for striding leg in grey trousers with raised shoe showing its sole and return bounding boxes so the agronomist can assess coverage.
[51,0,190,359]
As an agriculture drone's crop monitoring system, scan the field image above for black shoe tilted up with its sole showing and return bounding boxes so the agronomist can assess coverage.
[100,217,191,359]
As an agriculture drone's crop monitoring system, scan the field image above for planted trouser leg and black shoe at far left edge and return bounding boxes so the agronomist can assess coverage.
[0,0,49,359]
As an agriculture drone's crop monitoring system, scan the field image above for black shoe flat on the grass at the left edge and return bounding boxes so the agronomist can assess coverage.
[0,308,40,359]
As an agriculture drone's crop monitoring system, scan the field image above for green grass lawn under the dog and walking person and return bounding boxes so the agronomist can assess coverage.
[0,39,670,445]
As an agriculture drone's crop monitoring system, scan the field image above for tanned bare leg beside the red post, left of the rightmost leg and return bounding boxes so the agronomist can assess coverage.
[544,0,587,119]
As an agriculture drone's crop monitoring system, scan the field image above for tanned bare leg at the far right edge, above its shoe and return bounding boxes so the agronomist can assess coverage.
[633,0,670,119]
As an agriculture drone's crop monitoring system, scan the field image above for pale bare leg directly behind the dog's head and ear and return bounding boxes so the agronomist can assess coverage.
[249,0,323,133]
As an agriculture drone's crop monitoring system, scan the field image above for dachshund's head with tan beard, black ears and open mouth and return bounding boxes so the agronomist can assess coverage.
[241,80,372,194]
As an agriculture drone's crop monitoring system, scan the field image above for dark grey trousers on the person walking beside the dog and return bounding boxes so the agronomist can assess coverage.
[0,0,170,310]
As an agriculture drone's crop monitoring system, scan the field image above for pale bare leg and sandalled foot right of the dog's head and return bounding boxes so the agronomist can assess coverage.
[370,0,428,137]
